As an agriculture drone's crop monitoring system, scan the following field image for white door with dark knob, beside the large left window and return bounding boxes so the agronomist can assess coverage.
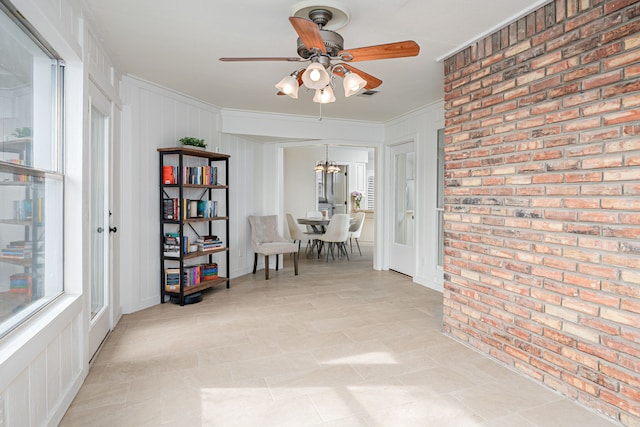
[89,85,112,359]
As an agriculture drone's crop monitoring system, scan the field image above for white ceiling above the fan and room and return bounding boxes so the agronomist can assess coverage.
[84,0,544,122]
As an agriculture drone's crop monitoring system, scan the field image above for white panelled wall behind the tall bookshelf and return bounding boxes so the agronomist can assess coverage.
[120,77,259,313]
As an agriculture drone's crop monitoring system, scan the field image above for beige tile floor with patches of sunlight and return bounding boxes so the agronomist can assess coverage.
[61,247,615,427]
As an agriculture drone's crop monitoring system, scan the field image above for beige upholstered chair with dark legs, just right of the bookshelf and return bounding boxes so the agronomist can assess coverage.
[249,215,298,280]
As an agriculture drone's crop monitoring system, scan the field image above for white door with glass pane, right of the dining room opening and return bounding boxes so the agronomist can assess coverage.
[389,143,416,277]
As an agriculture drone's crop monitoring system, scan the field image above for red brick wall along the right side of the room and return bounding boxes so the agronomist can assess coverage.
[444,0,640,425]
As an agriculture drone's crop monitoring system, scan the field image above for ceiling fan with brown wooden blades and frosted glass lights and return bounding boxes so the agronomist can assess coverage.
[220,6,420,104]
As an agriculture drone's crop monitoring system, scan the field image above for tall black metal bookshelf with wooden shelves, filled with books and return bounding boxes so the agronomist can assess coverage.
[158,147,230,305]
